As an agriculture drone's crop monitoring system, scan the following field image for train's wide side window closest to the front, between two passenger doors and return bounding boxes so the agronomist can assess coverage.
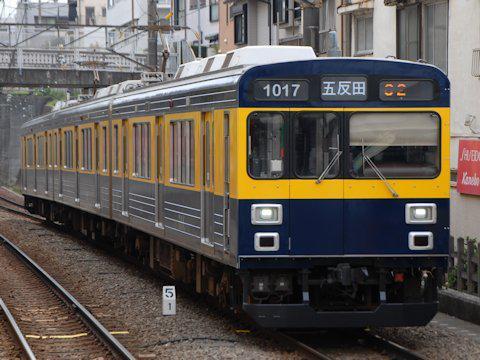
[170,120,195,185]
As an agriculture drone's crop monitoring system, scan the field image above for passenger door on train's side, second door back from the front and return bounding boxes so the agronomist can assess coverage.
[200,112,214,252]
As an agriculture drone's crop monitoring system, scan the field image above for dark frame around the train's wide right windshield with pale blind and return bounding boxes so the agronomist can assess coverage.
[343,111,443,180]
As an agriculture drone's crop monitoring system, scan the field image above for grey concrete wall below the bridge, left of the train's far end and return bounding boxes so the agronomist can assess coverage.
[0,94,48,185]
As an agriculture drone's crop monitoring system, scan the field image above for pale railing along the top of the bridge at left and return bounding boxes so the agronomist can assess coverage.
[0,47,146,72]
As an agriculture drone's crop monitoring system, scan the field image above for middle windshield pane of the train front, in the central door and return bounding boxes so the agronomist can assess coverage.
[293,112,340,178]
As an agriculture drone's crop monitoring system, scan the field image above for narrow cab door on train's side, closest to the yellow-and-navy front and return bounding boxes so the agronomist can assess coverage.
[223,111,230,253]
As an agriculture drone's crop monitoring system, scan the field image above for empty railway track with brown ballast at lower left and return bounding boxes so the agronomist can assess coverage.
[0,235,134,359]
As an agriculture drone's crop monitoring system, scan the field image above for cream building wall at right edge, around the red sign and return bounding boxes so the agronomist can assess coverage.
[448,0,480,241]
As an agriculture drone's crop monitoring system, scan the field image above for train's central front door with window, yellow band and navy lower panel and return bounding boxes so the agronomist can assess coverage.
[287,109,344,256]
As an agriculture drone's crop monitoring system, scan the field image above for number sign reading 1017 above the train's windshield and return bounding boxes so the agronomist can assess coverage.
[253,79,309,101]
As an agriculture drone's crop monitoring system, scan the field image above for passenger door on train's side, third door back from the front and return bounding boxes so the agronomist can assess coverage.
[155,116,165,229]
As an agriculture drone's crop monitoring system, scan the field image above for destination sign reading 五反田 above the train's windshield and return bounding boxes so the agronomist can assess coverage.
[321,76,367,101]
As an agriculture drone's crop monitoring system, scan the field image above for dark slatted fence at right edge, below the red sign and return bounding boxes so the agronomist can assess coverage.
[447,237,480,296]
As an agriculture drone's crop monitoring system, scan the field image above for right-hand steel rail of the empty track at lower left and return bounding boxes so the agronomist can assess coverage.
[0,234,135,360]
